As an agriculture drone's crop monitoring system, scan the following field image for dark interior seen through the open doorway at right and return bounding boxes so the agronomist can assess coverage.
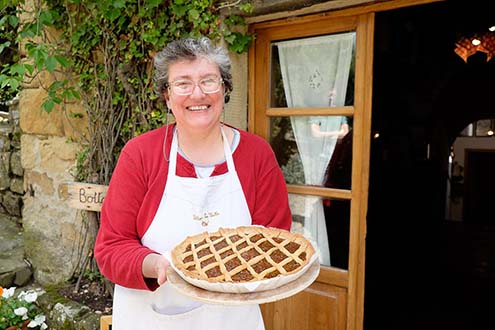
[364,0,495,330]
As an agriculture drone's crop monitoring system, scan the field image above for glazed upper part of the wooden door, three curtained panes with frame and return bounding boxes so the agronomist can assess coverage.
[249,11,371,283]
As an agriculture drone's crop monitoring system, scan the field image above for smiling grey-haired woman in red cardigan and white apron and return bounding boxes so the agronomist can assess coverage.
[95,38,291,330]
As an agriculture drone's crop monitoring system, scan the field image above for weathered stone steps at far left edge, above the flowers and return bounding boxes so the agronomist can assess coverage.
[0,214,33,288]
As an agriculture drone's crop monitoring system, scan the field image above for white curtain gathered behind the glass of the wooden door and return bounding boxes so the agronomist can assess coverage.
[276,32,355,265]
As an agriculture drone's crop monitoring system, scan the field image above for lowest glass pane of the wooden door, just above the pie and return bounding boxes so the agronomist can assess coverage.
[289,194,350,269]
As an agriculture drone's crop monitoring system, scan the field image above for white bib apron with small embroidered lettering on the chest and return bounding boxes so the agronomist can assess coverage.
[112,130,264,330]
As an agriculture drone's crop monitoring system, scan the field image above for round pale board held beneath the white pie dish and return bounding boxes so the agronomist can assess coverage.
[167,258,320,305]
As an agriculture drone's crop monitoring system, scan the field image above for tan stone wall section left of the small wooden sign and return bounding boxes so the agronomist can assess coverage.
[19,96,87,284]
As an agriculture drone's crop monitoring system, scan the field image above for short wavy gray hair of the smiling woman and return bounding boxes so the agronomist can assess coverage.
[153,37,233,103]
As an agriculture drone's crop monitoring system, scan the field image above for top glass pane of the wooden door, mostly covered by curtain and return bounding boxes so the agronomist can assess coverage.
[270,32,355,108]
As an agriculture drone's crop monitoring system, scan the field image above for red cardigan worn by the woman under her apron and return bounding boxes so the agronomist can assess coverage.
[94,124,292,290]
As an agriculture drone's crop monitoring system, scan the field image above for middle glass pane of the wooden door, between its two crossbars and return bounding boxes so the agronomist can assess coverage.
[270,116,352,189]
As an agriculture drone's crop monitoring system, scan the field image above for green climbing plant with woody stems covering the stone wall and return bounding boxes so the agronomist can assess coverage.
[0,0,253,292]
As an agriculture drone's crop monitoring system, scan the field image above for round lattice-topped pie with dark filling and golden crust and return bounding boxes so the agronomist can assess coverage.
[172,226,315,283]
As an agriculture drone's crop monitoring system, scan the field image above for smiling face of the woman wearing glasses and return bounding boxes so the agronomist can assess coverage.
[165,57,224,130]
